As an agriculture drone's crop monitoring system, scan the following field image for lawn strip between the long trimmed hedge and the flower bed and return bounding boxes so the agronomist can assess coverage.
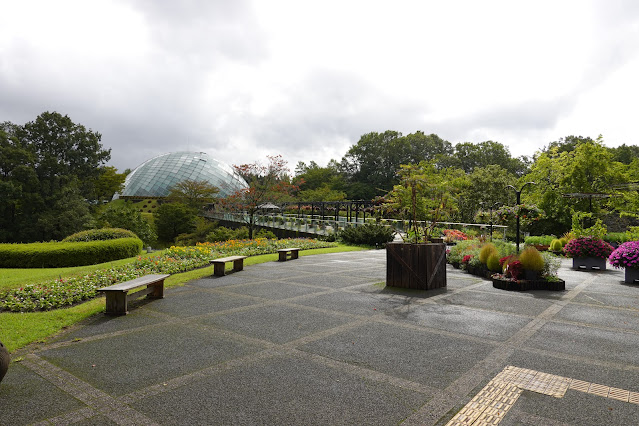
[0,253,152,290]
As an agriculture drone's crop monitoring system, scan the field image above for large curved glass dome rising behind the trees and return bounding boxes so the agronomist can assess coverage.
[120,152,248,198]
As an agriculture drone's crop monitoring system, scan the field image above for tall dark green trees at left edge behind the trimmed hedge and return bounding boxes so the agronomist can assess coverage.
[0,112,110,242]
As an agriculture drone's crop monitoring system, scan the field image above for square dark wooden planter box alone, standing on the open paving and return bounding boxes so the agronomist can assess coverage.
[386,243,446,290]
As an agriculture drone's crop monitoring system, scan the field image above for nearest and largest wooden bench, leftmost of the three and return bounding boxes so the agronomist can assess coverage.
[98,274,170,315]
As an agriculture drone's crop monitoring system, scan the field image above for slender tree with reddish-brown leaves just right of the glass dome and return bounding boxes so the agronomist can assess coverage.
[220,155,299,238]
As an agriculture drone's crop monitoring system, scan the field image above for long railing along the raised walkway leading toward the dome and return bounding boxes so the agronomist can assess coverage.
[205,212,507,239]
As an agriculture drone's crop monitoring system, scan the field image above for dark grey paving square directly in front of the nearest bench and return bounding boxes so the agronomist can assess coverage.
[40,324,263,395]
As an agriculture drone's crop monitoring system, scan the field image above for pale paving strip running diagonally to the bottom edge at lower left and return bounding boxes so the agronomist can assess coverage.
[22,354,157,425]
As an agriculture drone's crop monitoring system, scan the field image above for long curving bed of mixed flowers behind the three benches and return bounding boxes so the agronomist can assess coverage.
[0,238,336,312]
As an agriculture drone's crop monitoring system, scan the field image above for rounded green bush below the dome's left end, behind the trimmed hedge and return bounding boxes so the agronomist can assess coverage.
[95,201,157,245]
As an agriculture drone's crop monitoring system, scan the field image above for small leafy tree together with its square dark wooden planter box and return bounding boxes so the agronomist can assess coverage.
[383,161,452,290]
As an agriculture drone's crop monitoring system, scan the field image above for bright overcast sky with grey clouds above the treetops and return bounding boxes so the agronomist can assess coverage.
[0,0,639,171]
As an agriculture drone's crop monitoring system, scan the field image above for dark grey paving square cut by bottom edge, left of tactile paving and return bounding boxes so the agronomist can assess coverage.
[133,357,428,425]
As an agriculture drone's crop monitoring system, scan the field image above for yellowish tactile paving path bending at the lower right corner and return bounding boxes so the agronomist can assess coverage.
[447,365,639,426]
